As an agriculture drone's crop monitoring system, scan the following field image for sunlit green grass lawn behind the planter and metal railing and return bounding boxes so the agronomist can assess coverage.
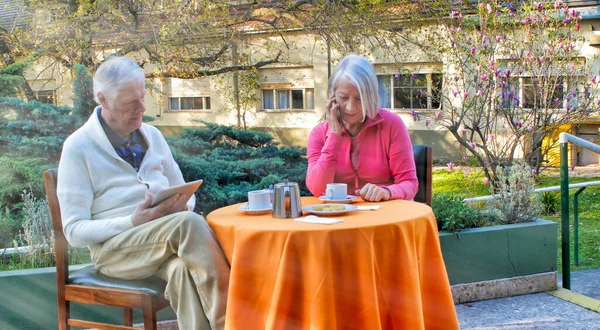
[433,168,600,271]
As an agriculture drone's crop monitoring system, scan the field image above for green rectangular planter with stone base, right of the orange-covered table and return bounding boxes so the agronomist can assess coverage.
[440,219,558,302]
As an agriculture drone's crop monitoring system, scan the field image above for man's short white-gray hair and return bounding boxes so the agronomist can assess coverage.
[94,56,146,104]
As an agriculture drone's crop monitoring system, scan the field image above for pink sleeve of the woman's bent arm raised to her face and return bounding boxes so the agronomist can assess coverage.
[306,123,342,196]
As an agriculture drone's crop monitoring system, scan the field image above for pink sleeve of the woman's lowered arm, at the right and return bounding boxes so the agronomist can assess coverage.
[386,118,419,200]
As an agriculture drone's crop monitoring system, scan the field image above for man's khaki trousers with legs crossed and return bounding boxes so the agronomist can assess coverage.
[90,212,230,330]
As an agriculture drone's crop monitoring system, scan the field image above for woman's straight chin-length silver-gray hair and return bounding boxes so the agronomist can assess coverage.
[328,54,380,121]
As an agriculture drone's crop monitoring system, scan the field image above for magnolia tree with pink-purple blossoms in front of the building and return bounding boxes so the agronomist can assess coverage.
[406,1,599,181]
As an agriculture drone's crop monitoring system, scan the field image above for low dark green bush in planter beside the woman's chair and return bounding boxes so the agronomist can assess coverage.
[432,194,483,232]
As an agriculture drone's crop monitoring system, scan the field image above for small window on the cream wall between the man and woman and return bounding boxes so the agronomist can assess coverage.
[262,88,315,110]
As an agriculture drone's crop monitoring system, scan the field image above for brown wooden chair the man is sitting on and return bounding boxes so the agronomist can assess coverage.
[44,170,169,330]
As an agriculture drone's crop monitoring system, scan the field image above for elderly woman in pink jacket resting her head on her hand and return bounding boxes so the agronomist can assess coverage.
[306,55,418,202]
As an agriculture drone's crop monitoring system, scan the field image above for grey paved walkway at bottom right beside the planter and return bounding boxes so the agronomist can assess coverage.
[456,269,600,330]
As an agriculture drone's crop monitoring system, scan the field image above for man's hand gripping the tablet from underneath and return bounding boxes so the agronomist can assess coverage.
[131,194,190,226]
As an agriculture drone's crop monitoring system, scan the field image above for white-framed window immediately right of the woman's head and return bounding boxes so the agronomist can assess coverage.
[377,73,442,109]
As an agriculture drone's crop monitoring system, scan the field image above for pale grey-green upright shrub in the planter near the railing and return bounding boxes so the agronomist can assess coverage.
[488,161,542,224]
